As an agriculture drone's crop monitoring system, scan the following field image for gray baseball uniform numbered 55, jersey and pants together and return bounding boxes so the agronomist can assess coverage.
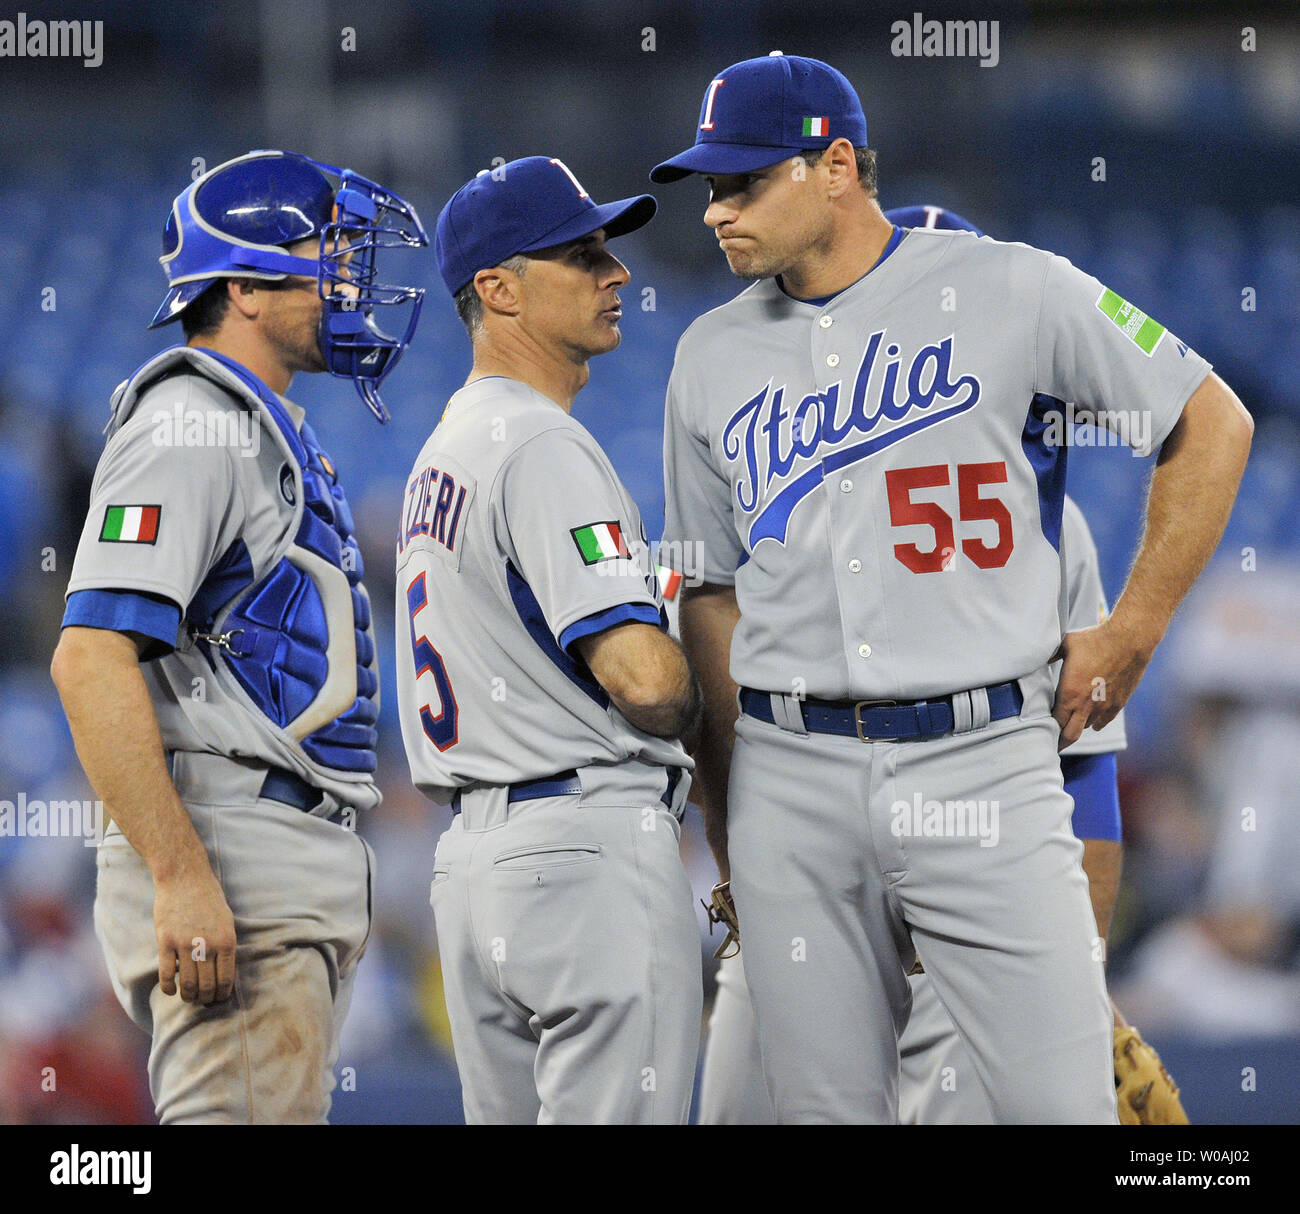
[664,230,1208,1124]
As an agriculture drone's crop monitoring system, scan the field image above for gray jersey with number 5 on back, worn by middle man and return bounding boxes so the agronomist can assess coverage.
[397,376,692,803]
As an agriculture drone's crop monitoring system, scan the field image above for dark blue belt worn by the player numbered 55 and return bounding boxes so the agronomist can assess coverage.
[740,682,1024,742]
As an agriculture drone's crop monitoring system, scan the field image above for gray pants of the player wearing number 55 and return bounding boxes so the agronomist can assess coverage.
[728,680,1115,1124]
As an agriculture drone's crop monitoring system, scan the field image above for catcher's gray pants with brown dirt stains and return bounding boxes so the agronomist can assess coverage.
[95,754,374,1124]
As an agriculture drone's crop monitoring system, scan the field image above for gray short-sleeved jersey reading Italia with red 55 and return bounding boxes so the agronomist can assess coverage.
[664,229,1209,699]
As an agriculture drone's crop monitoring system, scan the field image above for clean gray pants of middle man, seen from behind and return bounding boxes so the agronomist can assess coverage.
[429,781,703,1124]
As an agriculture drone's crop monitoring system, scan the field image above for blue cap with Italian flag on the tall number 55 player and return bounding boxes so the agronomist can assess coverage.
[650,51,867,182]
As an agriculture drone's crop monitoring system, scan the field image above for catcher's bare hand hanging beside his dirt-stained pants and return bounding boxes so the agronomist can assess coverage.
[153,871,235,1003]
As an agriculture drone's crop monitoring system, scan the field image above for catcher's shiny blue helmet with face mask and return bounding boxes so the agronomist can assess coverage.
[150,151,429,422]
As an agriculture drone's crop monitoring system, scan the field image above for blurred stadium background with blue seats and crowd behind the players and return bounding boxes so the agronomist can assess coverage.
[0,0,1300,1123]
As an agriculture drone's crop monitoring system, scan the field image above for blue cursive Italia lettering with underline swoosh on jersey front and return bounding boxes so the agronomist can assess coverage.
[723,329,980,551]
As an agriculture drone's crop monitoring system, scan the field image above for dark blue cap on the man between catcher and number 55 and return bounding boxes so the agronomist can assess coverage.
[433,156,659,295]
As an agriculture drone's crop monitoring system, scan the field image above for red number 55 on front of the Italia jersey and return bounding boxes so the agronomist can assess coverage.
[885,460,1015,573]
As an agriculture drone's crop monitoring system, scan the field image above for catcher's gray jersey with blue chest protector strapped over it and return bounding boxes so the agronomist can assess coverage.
[64,347,380,812]
